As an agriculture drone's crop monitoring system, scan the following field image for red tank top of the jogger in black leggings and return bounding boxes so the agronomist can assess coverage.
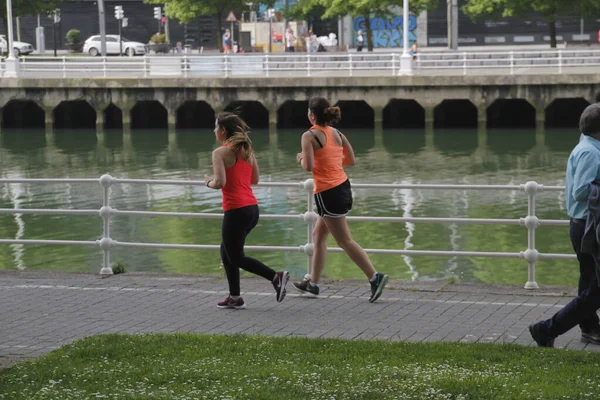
[221,144,258,211]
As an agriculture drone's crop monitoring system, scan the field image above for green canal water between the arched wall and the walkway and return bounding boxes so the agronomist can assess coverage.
[0,129,579,285]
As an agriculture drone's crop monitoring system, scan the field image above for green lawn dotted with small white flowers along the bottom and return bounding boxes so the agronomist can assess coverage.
[0,334,600,400]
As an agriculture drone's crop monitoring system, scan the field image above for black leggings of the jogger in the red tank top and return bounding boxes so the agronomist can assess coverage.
[221,206,276,296]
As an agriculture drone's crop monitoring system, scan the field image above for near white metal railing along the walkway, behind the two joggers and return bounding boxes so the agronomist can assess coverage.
[0,175,576,289]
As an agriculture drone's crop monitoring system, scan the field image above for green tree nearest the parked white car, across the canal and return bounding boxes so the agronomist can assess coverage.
[144,0,273,48]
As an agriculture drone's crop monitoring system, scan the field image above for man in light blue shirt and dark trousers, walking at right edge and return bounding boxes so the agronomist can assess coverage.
[529,103,600,347]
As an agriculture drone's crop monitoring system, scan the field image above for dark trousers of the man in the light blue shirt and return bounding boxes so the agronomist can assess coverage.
[543,220,600,338]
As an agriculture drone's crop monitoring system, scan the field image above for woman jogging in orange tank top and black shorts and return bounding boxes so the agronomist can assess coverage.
[294,98,388,303]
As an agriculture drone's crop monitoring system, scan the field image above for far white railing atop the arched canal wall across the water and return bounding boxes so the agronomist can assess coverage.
[9,49,600,78]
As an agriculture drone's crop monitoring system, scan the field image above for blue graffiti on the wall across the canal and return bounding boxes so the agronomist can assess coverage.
[354,15,417,47]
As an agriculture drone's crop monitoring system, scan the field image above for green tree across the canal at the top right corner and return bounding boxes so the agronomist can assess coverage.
[462,0,600,48]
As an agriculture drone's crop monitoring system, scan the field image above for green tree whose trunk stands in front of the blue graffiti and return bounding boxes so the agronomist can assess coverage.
[292,0,438,51]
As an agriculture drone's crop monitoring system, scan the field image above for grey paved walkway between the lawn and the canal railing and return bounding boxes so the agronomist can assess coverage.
[0,272,600,367]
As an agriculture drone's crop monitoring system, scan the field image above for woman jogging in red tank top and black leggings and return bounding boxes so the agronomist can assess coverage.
[205,113,289,309]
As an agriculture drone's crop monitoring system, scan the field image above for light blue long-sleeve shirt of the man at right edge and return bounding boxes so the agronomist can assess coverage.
[565,136,600,219]
